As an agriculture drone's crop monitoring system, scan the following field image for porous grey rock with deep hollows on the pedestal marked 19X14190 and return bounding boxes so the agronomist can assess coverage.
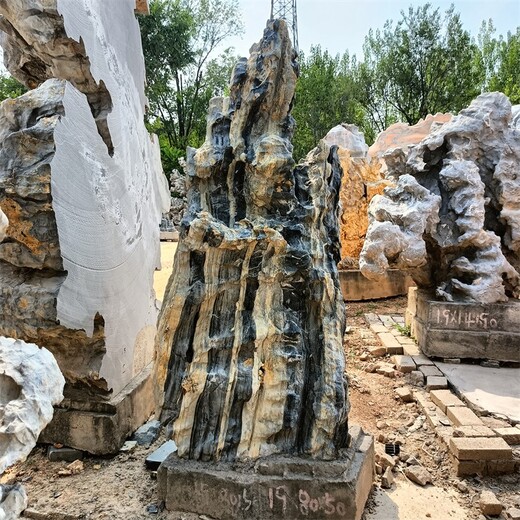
[360,92,520,304]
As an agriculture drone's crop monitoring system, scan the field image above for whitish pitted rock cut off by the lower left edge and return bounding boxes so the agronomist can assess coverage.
[0,336,65,520]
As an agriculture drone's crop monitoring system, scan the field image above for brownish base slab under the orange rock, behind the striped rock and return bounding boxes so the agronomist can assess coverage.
[339,269,415,302]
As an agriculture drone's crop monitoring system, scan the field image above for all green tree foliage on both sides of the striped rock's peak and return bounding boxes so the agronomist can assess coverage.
[139,0,520,167]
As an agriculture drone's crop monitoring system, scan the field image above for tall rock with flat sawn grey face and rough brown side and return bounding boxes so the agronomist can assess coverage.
[0,0,168,399]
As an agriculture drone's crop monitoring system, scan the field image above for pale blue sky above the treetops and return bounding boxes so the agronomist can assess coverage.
[226,0,520,57]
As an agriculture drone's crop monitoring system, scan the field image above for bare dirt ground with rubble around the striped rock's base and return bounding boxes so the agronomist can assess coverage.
[0,243,520,520]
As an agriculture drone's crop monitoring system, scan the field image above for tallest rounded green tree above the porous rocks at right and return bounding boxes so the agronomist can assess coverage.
[358,4,483,131]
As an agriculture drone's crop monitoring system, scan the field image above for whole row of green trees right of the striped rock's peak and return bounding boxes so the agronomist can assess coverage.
[294,4,520,159]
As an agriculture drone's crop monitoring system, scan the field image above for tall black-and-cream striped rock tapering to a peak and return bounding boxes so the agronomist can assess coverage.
[157,21,348,460]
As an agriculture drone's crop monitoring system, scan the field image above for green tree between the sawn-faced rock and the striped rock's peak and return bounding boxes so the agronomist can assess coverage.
[139,0,242,172]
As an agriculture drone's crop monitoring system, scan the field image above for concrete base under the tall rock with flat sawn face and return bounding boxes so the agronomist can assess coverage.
[38,364,155,455]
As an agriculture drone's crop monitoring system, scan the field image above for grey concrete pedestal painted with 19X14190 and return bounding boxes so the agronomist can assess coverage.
[406,288,520,363]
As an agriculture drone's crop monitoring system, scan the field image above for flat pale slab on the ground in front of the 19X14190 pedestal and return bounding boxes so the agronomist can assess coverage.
[435,363,520,422]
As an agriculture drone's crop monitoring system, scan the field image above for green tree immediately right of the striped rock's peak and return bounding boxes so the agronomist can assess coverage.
[293,45,363,160]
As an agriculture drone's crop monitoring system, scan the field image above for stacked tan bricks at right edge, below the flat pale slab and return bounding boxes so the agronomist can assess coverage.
[415,390,520,476]
